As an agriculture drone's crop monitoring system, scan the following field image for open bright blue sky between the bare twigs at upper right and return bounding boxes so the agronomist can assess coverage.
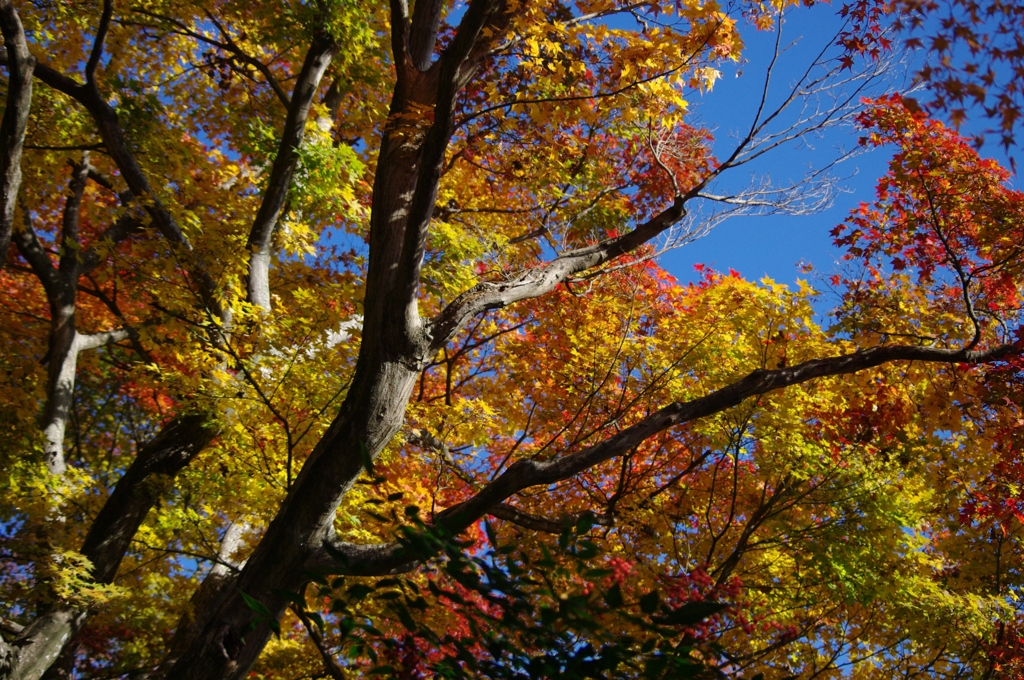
[662,5,888,284]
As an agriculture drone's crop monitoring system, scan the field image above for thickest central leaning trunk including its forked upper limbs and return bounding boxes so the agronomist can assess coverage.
[157,0,509,680]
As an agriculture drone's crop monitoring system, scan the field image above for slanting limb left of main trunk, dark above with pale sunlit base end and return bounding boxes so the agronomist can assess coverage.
[248,35,337,309]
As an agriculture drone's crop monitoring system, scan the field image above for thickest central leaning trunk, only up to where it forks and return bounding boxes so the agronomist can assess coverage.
[157,71,434,680]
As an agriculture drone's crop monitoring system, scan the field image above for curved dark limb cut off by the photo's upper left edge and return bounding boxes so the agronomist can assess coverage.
[0,0,36,268]
